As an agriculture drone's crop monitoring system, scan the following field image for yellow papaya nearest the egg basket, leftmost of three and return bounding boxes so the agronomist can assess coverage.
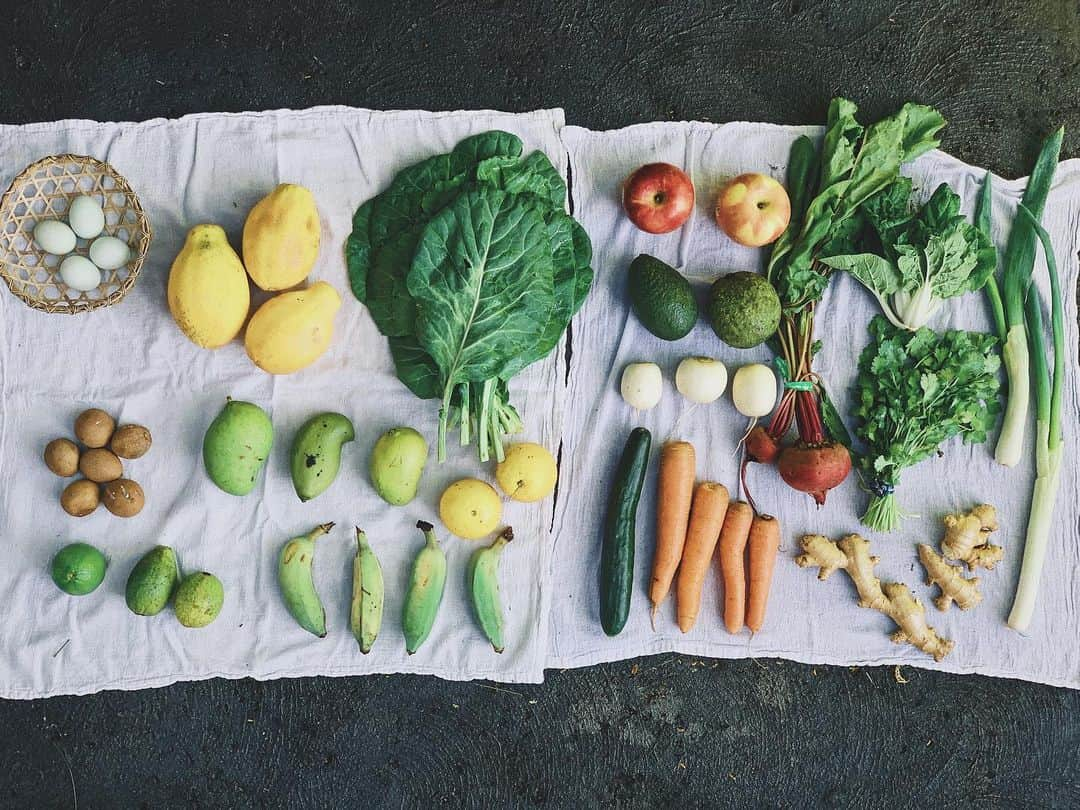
[168,225,251,349]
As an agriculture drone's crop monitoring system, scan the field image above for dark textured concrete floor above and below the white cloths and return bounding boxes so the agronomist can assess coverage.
[0,0,1080,808]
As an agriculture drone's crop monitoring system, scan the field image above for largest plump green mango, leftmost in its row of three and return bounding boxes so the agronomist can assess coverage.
[203,399,273,495]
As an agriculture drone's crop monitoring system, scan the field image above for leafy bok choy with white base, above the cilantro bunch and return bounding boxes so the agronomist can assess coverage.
[822,177,997,332]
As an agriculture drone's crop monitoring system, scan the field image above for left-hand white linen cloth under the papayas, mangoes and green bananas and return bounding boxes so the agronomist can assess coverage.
[0,108,566,698]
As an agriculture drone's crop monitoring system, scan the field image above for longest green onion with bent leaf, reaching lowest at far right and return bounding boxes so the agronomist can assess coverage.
[1009,203,1065,632]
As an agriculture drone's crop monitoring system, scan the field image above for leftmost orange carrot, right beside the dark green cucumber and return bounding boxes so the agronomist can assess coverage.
[649,442,696,619]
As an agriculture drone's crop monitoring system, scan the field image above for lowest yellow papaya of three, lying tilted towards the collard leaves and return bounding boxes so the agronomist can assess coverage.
[244,281,341,374]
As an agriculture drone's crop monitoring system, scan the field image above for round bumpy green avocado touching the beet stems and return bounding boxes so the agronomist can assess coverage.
[708,272,780,349]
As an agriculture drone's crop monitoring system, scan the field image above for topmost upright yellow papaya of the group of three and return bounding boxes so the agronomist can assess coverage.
[243,183,320,291]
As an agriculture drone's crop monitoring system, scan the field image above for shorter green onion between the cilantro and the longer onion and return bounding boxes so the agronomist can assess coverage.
[988,127,1065,467]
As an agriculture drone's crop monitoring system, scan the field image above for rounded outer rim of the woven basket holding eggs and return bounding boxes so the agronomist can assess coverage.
[0,152,153,315]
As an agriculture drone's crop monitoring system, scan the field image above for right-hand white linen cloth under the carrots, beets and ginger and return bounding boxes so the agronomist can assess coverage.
[549,123,1080,688]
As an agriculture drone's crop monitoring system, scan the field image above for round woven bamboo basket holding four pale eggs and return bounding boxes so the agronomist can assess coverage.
[0,154,152,314]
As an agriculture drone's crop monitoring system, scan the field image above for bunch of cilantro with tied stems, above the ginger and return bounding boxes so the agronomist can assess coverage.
[854,315,1001,531]
